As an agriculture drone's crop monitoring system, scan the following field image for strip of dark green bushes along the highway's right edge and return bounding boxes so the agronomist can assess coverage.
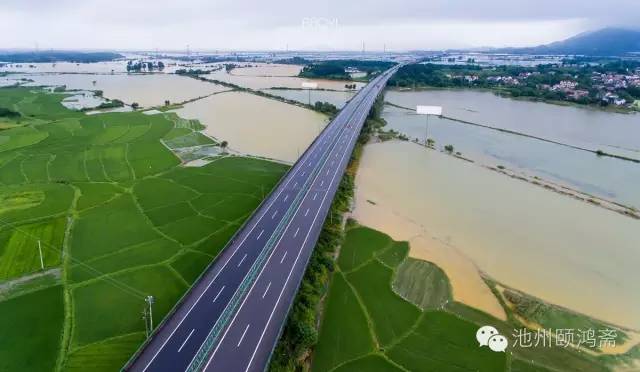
[269,92,384,371]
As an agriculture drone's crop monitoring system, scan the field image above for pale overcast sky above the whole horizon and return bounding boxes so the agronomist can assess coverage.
[0,0,640,50]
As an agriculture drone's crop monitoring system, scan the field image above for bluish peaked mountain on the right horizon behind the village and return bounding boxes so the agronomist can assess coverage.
[492,28,640,56]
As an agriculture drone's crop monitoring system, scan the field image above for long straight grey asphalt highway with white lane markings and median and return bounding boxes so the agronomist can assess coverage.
[124,68,396,372]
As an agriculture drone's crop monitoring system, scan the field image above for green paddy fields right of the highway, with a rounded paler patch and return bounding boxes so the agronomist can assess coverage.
[311,225,632,372]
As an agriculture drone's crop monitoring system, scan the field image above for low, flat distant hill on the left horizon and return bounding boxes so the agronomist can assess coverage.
[0,50,123,63]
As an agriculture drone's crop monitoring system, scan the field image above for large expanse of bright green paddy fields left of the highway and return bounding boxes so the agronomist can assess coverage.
[0,88,287,371]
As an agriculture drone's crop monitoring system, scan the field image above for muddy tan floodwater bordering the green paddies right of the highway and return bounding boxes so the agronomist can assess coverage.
[355,141,640,329]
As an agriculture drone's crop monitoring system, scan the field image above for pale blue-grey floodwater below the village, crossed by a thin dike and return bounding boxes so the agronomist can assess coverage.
[383,90,640,208]
